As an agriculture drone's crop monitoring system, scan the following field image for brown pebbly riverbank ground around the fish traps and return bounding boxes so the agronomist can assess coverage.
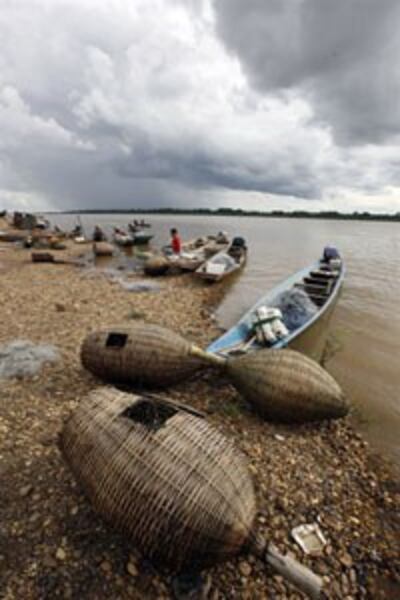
[0,229,400,600]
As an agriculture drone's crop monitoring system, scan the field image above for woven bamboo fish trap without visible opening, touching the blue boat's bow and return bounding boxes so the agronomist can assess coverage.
[222,350,349,423]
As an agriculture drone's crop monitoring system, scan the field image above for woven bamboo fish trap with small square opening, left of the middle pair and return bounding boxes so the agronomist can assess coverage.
[81,323,204,387]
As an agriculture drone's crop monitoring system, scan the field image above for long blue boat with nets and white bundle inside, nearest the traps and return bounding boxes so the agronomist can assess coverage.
[207,248,345,361]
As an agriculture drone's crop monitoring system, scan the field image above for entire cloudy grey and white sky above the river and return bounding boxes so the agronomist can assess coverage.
[0,0,400,212]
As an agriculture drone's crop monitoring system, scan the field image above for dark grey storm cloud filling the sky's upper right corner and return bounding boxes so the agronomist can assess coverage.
[215,0,400,145]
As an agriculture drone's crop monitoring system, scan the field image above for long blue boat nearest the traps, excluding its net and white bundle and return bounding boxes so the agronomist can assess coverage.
[207,254,345,361]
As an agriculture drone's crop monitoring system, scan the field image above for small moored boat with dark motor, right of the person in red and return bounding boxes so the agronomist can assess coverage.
[195,238,247,281]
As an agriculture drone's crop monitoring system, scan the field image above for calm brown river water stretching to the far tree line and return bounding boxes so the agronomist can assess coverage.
[51,214,400,473]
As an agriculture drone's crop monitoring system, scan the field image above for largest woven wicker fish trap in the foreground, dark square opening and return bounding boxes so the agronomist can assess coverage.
[60,388,256,570]
